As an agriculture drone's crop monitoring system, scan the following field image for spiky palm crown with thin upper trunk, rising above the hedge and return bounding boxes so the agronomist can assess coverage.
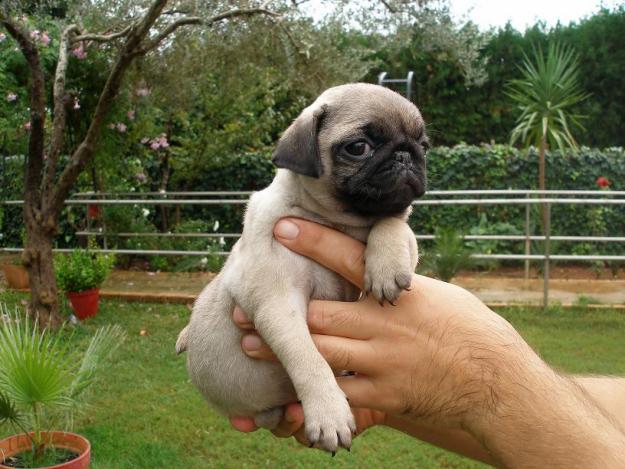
[507,43,589,190]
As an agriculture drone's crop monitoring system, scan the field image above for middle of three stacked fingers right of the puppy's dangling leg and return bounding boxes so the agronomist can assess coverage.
[312,334,379,374]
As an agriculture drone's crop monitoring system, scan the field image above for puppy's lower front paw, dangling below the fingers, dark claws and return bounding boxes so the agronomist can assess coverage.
[302,386,356,453]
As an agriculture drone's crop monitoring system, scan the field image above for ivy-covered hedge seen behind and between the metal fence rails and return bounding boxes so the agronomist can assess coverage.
[0,144,625,254]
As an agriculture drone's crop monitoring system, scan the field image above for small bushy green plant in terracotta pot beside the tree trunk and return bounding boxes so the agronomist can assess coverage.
[54,249,115,319]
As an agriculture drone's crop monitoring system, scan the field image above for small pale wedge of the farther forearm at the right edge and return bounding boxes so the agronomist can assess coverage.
[571,376,625,431]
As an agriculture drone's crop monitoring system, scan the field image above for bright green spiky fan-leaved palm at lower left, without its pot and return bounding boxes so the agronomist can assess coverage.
[0,303,125,466]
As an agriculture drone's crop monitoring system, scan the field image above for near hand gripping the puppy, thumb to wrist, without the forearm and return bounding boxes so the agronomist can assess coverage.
[235,219,542,434]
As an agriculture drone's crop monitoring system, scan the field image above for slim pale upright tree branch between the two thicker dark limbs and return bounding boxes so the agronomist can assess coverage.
[43,24,78,203]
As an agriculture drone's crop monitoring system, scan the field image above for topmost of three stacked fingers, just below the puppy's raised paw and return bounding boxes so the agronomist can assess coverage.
[307,299,388,340]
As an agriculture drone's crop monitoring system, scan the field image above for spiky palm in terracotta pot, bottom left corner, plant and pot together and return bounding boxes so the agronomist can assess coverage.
[0,304,125,469]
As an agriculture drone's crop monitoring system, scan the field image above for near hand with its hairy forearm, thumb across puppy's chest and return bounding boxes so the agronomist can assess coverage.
[230,219,625,467]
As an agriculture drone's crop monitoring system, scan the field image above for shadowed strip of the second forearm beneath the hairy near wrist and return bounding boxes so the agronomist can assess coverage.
[384,416,495,465]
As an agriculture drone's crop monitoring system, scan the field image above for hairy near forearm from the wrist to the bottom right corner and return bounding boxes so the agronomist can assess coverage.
[471,355,625,468]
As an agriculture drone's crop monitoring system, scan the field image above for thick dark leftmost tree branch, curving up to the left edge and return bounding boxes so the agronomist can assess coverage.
[0,10,46,214]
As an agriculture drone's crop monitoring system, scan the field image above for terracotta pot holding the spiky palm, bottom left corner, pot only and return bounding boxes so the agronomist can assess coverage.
[0,432,91,469]
